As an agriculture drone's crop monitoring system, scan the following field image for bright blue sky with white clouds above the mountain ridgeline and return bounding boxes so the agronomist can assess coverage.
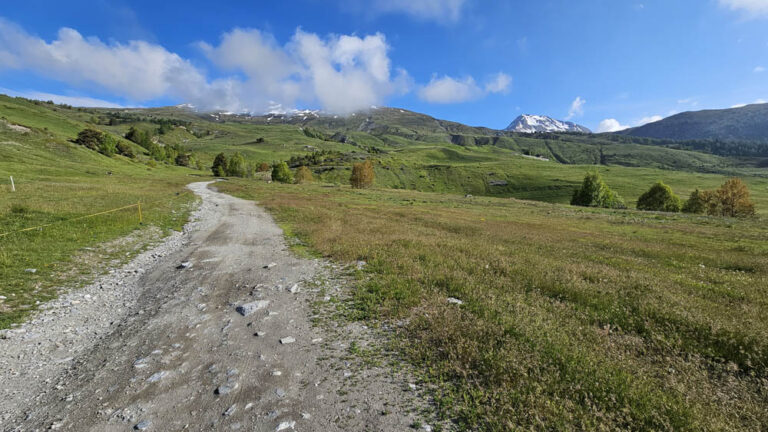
[0,0,768,130]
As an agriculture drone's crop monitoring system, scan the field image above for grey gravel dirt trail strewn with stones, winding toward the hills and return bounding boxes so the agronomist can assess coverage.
[0,183,424,431]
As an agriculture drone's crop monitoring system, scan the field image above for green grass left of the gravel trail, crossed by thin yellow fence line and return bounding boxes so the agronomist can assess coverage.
[0,101,196,329]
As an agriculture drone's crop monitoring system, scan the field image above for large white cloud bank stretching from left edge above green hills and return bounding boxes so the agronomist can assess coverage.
[0,19,410,114]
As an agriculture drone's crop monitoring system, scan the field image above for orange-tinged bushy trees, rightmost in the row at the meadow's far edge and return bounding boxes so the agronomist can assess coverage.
[683,178,755,217]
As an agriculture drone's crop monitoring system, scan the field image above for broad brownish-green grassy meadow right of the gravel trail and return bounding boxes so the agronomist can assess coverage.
[218,181,768,431]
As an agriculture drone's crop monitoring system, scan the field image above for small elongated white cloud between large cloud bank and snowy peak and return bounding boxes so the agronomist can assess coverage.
[419,72,512,104]
